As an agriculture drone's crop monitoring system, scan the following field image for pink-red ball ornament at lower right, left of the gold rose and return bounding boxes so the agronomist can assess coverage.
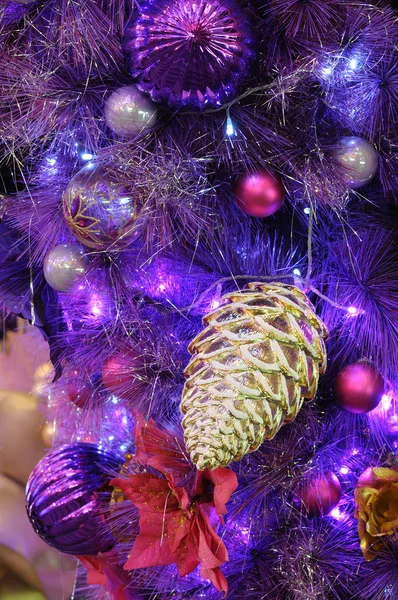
[297,471,341,517]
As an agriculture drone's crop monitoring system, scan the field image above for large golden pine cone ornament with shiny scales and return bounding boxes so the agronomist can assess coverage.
[181,282,327,470]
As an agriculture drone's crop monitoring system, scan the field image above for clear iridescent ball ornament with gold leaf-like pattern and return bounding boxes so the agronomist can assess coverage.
[63,163,141,250]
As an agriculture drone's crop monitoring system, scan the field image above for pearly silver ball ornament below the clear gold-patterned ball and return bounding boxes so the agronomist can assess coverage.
[43,244,88,292]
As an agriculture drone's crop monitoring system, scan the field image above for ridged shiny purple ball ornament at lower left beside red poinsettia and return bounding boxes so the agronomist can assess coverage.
[26,443,120,556]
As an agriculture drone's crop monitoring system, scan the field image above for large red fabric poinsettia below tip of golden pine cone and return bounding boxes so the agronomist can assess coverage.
[111,422,238,594]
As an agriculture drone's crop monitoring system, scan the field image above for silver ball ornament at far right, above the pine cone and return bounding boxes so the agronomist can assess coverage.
[333,136,379,189]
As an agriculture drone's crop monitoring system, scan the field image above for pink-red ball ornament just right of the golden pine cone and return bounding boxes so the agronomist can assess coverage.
[334,362,384,414]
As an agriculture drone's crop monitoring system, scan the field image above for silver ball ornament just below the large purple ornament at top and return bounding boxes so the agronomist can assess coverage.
[104,85,156,137]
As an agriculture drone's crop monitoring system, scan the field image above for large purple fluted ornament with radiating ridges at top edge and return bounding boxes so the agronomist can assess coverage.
[125,0,252,108]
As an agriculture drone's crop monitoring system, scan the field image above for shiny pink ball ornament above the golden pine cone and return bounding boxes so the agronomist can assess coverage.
[234,171,285,218]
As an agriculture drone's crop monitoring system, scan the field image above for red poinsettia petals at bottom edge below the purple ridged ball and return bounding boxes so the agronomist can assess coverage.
[77,550,139,600]
